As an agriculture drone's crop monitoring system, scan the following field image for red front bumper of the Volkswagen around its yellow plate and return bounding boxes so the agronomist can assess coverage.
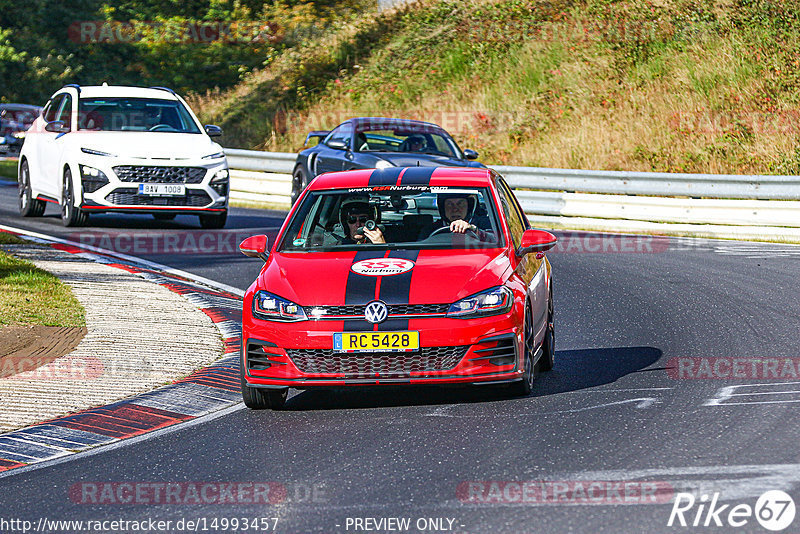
[242,301,522,388]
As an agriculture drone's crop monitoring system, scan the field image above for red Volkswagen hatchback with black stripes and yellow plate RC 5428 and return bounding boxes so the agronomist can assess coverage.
[240,167,556,409]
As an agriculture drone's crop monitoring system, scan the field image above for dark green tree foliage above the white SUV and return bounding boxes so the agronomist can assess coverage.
[0,0,370,104]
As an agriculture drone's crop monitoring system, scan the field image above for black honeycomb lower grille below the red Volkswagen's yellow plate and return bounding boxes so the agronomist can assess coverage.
[286,346,469,377]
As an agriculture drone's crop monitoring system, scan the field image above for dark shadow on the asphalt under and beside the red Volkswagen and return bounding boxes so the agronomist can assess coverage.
[284,347,662,411]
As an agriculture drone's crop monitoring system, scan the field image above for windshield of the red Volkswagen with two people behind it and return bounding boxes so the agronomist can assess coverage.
[278,186,503,252]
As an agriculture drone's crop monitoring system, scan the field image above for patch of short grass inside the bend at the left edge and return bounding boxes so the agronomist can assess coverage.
[0,249,86,326]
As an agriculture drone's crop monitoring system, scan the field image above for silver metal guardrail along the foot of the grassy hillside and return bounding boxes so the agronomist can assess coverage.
[225,149,800,241]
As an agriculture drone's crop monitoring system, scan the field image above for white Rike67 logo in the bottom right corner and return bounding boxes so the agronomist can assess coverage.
[667,490,796,532]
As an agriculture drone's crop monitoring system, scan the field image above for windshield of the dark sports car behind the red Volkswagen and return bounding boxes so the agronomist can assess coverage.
[355,124,461,159]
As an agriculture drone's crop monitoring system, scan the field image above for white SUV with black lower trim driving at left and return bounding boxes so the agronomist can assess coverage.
[18,84,229,228]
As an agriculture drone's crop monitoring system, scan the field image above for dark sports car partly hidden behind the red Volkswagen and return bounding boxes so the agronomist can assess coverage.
[292,117,484,204]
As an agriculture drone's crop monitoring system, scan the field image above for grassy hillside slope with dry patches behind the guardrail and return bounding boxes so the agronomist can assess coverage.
[193,0,800,174]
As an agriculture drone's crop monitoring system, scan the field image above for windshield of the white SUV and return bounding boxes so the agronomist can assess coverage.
[78,98,200,133]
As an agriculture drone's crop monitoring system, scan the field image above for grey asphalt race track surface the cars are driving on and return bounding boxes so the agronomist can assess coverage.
[0,178,800,533]
